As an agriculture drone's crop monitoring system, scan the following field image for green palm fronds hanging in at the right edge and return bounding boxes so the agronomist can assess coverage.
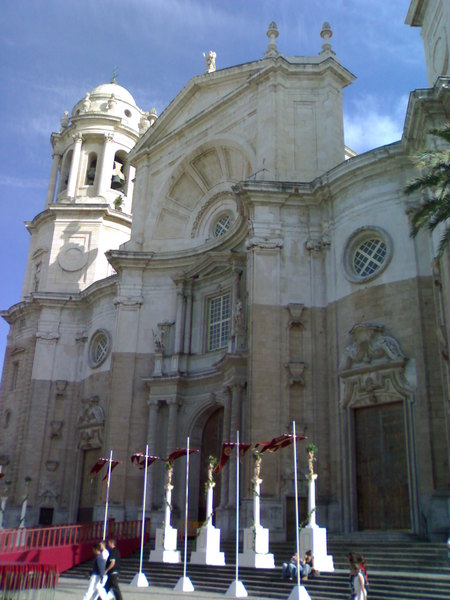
[405,123,450,258]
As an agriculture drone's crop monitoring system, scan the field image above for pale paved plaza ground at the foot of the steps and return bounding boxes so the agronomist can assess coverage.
[55,576,267,600]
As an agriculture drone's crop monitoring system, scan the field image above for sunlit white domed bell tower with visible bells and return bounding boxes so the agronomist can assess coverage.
[22,82,156,298]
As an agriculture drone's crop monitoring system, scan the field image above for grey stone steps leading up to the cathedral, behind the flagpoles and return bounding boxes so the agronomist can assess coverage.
[63,534,450,600]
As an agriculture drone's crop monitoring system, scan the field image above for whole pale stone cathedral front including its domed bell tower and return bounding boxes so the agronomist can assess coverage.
[0,0,450,540]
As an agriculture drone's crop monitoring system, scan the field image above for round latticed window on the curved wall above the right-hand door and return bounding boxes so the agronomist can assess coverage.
[344,227,392,283]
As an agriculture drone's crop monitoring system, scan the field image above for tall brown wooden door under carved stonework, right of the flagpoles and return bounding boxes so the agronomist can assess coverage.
[354,402,411,530]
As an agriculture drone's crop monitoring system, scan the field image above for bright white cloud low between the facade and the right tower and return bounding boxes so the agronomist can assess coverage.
[344,95,408,152]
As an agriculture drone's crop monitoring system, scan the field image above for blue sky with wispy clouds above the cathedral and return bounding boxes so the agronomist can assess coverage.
[0,0,427,364]
